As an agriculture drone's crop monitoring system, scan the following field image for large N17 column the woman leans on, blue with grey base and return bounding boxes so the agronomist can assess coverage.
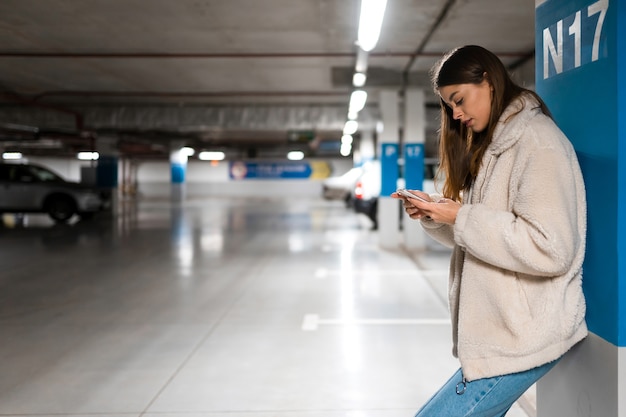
[535,0,626,417]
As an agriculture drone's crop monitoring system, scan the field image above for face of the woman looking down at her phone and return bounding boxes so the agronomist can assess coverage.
[439,79,492,132]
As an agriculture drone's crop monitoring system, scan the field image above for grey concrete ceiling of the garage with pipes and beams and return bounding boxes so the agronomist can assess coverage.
[0,0,535,158]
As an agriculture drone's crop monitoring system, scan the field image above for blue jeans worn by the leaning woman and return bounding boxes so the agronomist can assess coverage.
[415,359,559,417]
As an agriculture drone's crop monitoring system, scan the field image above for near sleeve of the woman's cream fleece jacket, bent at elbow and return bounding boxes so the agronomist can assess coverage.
[454,133,586,276]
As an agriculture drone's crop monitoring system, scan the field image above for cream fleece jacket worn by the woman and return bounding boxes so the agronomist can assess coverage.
[422,95,587,381]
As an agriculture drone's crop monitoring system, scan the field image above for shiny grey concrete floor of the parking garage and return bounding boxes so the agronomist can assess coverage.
[0,198,527,417]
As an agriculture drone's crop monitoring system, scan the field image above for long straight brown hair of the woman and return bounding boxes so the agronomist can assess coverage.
[431,45,550,201]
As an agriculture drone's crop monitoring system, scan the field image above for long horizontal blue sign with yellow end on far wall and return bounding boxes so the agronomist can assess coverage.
[228,161,313,180]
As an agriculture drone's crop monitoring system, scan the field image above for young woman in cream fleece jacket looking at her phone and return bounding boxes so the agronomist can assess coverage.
[392,46,587,417]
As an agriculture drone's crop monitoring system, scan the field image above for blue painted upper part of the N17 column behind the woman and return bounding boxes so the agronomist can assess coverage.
[535,0,626,346]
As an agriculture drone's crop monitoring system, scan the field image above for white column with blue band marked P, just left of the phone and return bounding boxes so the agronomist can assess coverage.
[378,90,400,248]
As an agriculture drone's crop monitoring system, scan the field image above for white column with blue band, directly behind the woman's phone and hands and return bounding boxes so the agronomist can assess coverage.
[402,89,426,250]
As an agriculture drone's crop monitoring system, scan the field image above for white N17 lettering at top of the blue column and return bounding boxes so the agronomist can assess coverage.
[543,0,609,80]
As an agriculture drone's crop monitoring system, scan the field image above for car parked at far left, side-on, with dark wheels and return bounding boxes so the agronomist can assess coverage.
[0,162,103,223]
